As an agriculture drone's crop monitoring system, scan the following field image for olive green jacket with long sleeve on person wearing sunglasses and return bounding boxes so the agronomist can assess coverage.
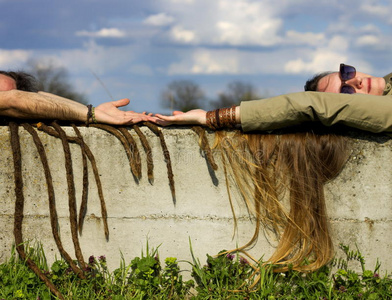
[240,73,392,132]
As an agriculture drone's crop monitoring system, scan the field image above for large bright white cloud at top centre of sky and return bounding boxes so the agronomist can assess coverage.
[150,0,283,46]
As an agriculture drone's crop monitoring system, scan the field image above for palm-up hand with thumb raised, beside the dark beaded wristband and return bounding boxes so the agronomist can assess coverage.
[95,98,156,125]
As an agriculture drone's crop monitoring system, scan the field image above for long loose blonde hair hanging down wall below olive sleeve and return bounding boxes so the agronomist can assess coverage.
[214,127,348,271]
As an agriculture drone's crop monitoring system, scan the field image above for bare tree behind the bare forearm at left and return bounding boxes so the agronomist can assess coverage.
[27,60,88,104]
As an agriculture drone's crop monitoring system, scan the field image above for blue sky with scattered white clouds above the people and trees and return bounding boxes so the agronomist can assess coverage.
[0,0,392,112]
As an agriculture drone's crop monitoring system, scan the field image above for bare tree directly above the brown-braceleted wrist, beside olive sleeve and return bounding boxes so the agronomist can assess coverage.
[210,81,261,109]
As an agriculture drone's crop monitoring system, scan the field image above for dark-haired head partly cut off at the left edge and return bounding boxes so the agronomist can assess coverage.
[0,71,38,92]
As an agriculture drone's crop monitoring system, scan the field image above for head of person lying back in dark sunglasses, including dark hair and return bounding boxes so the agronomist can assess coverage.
[305,64,385,96]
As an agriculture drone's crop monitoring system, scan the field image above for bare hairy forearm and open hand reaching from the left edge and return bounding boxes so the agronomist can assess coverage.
[0,90,153,125]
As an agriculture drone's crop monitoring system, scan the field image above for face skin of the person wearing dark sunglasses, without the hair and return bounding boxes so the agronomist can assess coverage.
[317,72,385,96]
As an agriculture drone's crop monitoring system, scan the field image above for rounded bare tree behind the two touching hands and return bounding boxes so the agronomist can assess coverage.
[161,80,205,111]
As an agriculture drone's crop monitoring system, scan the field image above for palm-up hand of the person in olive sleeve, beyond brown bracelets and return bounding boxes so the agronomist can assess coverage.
[151,109,206,126]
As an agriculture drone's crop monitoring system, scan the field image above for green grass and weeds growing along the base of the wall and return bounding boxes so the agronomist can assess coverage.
[0,244,392,300]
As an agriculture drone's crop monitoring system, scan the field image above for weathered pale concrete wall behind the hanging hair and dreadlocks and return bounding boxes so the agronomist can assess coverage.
[0,127,392,270]
